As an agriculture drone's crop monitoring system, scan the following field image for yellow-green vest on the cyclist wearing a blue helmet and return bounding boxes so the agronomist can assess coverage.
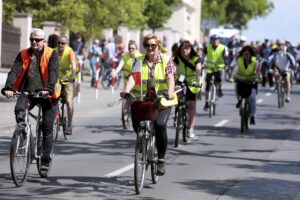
[205,44,225,74]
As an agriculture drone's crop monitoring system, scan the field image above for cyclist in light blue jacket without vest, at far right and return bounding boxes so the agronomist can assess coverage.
[269,40,296,103]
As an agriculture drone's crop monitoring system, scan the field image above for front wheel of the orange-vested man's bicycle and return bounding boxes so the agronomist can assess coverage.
[10,130,31,187]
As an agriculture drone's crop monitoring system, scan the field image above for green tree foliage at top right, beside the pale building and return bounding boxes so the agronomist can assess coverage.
[202,0,274,29]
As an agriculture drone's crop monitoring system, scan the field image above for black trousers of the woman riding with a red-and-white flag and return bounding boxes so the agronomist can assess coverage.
[132,107,171,159]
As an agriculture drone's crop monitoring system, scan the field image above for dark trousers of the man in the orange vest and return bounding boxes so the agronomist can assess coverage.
[15,96,58,160]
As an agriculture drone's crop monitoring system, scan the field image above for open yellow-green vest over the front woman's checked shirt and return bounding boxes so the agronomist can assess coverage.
[132,53,170,98]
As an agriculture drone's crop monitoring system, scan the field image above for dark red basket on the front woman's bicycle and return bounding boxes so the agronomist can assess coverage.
[131,101,158,121]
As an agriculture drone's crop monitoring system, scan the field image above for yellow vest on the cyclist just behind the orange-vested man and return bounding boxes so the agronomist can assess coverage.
[56,47,72,84]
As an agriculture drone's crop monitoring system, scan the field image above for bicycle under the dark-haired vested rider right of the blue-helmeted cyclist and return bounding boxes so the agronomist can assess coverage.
[237,80,254,133]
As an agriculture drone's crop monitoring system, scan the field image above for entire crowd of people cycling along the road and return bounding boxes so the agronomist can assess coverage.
[2,29,300,185]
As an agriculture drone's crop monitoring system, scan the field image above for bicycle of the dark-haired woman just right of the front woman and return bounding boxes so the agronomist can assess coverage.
[174,80,201,147]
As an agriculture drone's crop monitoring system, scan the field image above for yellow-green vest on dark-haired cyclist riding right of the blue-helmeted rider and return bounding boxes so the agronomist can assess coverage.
[236,56,256,80]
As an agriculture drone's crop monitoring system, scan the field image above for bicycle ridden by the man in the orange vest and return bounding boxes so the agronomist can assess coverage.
[6,90,52,187]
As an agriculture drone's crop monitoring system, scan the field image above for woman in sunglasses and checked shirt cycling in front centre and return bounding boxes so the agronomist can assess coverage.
[121,34,176,176]
